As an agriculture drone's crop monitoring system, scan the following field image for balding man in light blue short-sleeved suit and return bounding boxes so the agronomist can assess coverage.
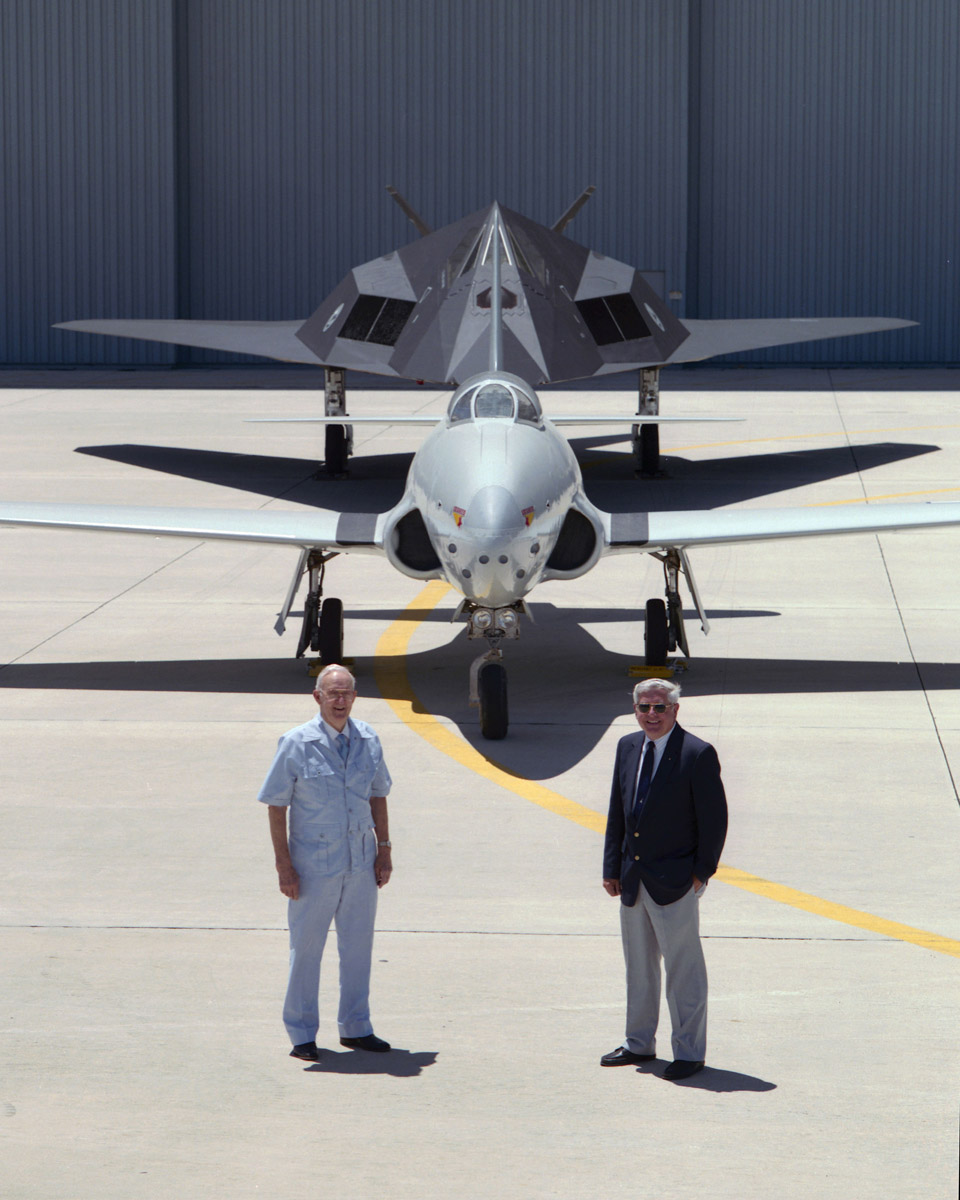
[258,664,392,1062]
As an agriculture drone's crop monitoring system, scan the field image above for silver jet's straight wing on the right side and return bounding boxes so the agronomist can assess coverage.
[601,503,960,553]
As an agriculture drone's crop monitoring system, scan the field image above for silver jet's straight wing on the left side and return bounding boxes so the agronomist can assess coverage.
[0,502,384,554]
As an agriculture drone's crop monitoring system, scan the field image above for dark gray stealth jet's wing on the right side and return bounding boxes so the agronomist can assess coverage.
[662,317,917,365]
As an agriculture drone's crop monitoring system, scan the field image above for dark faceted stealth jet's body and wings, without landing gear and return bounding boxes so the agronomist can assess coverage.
[59,196,913,386]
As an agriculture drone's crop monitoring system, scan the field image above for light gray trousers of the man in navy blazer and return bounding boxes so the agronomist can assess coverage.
[620,887,707,1062]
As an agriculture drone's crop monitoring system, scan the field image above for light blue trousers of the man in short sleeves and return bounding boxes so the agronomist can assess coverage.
[283,866,377,1045]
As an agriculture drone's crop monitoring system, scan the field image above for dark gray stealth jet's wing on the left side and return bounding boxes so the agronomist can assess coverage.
[54,320,320,366]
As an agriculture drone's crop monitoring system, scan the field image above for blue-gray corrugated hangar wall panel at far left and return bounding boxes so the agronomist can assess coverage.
[0,0,174,364]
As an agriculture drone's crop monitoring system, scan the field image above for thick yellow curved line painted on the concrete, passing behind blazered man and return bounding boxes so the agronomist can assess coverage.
[373,581,960,958]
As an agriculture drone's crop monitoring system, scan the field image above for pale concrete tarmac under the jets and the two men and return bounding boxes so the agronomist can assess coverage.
[0,367,960,1200]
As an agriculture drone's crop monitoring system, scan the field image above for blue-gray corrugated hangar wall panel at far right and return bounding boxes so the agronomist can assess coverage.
[688,0,960,362]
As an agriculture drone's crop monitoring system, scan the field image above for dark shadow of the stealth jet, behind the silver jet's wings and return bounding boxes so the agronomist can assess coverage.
[76,434,940,512]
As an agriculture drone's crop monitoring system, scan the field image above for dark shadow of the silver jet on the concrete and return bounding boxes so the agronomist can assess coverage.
[0,604,960,781]
